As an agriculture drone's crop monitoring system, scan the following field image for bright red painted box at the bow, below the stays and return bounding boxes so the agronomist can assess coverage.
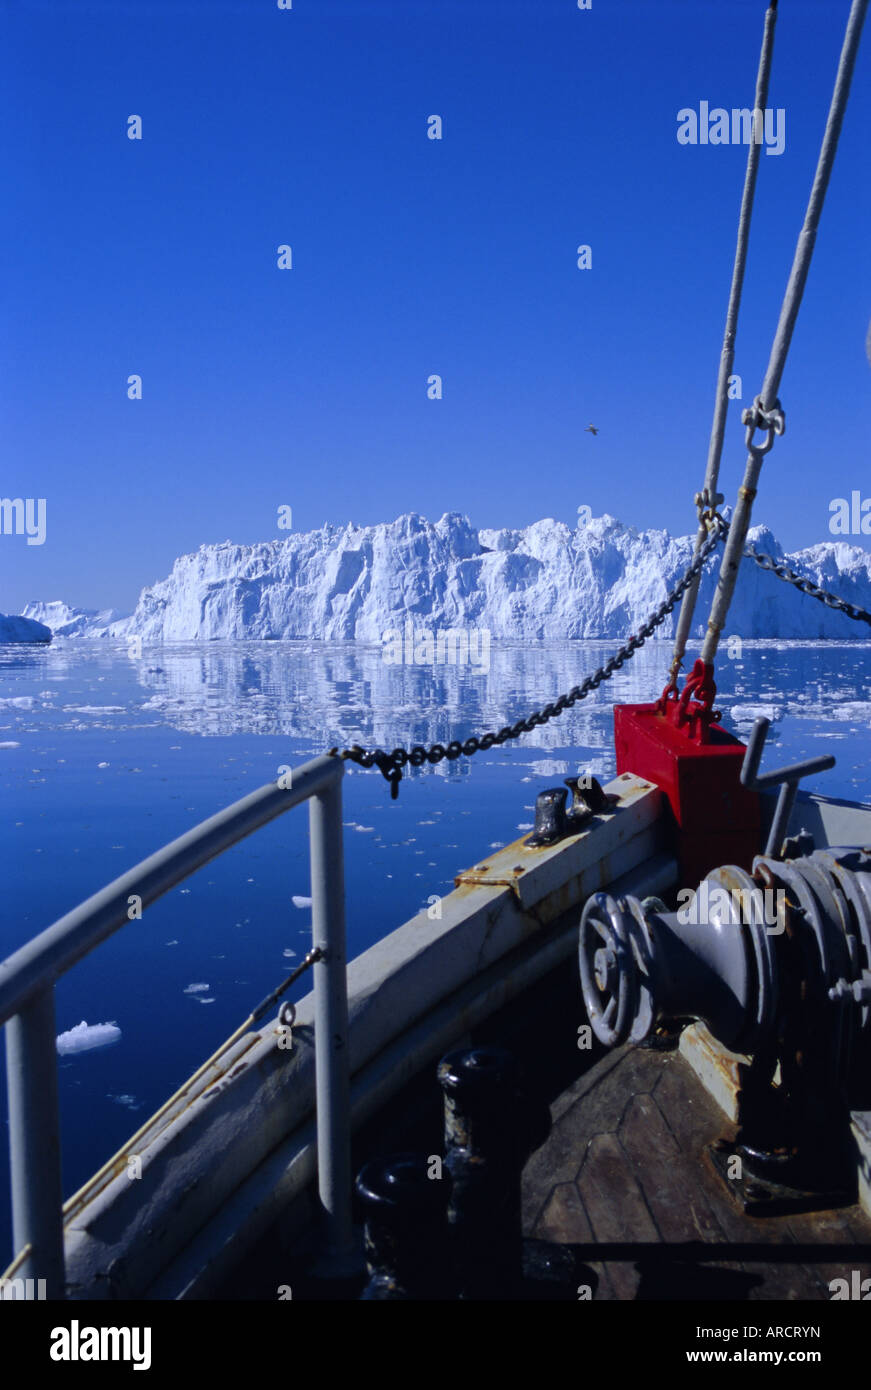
[614,705,763,888]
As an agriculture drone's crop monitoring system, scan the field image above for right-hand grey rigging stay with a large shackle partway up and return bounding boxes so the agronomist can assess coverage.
[702,0,868,664]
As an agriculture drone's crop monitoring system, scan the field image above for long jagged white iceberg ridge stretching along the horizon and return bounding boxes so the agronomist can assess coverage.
[25,512,871,644]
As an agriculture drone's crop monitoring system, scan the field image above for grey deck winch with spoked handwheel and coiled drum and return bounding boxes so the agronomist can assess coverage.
[579,847,871,1212]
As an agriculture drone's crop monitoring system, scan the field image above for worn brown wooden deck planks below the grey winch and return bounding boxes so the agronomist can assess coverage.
[524,1045,871,1301]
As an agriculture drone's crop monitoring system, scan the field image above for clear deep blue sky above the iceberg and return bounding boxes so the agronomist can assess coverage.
[0,0,871,613]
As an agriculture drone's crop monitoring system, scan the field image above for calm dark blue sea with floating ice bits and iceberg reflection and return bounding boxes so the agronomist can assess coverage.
[0,641,871,1268]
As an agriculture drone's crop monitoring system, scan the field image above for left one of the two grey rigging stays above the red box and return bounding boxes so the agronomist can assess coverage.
[668,0,777,689]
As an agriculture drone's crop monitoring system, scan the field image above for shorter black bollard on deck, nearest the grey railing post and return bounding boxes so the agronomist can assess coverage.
[357,1154,456,1302]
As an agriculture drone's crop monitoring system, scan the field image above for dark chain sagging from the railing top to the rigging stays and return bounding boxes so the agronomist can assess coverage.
[331,516,728,799]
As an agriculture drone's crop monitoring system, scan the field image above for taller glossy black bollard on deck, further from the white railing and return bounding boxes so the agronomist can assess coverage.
[439,1047,540,1300]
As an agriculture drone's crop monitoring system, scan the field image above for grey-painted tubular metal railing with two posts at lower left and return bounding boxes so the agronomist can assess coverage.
[0,753,351,1298]
